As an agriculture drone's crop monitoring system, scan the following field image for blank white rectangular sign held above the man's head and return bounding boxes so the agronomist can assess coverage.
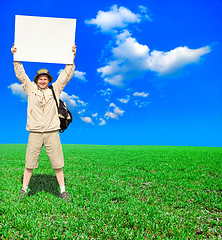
[14,15,76,64]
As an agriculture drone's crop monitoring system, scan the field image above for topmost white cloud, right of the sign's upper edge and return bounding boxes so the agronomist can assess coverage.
[85,5,141,32]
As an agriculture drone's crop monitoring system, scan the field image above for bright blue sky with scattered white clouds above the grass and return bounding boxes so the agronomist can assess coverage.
[0,0,222,147]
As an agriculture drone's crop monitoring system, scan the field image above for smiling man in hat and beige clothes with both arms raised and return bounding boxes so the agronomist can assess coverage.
[11,44,76,200]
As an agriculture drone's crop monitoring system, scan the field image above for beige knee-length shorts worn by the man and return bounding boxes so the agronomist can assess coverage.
[25,131,64,169]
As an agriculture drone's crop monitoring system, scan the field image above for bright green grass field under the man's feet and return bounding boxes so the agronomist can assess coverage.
[0,144,222,239]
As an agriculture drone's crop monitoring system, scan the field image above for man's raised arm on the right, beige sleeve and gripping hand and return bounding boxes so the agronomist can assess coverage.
[53,45,76,94]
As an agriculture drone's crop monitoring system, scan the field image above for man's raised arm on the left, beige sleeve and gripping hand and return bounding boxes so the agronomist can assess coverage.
[11,44,31,94]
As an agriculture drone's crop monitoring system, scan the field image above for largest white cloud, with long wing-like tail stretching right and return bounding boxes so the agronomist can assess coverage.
[97,31,211,86]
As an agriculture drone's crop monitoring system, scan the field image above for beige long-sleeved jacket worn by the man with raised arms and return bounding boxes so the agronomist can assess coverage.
[14,62,75,132]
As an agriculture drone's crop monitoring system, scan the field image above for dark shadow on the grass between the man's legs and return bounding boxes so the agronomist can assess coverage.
[22,174,59,196]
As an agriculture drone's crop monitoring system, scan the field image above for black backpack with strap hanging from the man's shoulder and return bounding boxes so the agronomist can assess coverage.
[49,85,72,133]
